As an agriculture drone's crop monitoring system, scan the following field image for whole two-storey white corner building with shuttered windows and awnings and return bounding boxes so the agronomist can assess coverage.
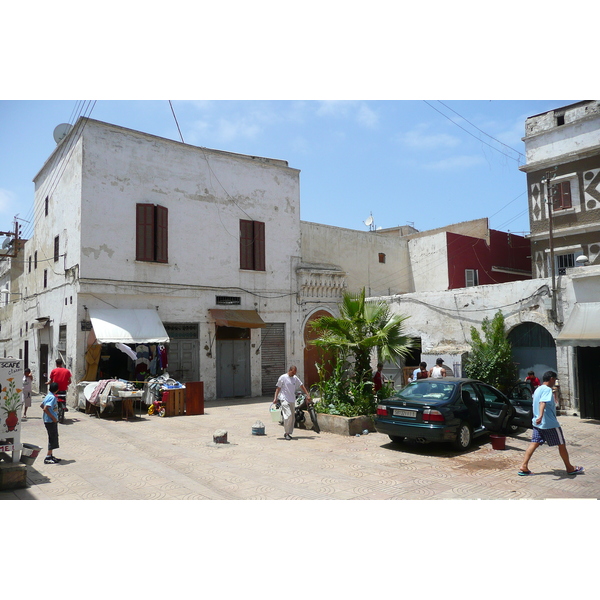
[0,119,310,398]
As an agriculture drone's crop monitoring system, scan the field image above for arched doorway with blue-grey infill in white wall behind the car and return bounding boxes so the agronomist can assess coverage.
[508,321,556,381]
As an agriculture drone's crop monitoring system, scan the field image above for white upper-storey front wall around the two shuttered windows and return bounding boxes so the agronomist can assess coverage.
[81,122,300,290]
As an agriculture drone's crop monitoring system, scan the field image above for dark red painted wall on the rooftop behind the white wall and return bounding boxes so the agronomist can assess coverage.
[446,229,531,289]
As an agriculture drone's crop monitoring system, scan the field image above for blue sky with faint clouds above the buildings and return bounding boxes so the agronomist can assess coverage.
[0,100,573,239]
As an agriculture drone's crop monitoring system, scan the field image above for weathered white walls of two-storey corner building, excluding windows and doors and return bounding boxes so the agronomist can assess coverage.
[2,119,310,399]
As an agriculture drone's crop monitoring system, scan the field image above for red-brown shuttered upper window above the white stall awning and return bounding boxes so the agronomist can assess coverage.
[135,204,169,263]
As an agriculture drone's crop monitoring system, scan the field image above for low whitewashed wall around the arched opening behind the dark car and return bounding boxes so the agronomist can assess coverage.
[386,266,600,411]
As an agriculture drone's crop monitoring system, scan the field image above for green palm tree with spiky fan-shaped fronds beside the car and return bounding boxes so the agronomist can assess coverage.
[312,288,413,382]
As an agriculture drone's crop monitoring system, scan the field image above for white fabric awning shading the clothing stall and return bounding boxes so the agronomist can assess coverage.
[90,308,169,344]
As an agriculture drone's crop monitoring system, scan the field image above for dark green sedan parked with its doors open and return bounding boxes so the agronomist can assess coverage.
[375,377,532,450]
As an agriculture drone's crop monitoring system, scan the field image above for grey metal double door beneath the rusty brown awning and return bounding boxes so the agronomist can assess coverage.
[216,327,252,398]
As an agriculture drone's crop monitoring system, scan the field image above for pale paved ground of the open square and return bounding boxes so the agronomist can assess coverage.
[0,398,600,500]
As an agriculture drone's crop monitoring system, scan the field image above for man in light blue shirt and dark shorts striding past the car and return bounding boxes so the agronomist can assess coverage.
[519,371,583,475]
